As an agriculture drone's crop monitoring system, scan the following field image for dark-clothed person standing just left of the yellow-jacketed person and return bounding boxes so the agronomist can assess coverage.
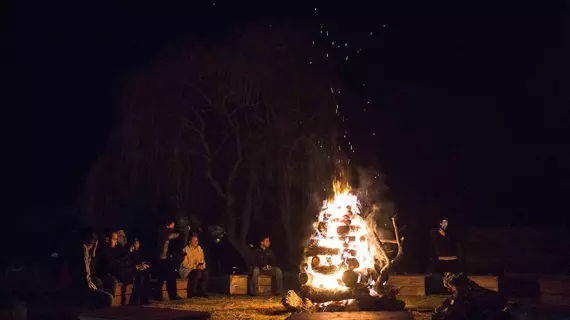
[155,219,182,301]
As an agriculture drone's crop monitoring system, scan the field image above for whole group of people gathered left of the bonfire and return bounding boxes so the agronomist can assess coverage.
[73,219,283,308]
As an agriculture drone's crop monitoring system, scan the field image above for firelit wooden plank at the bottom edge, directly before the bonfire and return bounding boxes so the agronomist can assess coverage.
[287,311,414,320]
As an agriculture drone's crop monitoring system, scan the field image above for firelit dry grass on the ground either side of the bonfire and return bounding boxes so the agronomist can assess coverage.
[152,296,444,320]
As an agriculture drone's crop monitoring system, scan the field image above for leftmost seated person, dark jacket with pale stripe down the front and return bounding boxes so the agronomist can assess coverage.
[69,229,113,308]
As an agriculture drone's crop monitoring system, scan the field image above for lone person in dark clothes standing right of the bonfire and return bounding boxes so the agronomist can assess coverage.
[430,219,459,274]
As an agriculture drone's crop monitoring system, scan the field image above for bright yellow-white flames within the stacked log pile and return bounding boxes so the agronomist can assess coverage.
[303,180,374,289]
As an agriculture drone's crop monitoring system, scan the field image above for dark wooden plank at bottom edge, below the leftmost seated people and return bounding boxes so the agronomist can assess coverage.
[79,307,210,320]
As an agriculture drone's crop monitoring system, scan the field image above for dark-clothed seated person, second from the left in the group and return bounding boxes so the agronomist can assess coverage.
[97,232,150,304]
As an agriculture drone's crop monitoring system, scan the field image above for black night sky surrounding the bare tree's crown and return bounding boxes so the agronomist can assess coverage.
[2,0,570,232]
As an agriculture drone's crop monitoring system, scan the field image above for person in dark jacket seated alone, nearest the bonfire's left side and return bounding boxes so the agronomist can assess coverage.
[249,237,283,296]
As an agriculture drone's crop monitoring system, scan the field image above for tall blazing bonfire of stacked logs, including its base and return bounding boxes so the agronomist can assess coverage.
[283,181,403,311]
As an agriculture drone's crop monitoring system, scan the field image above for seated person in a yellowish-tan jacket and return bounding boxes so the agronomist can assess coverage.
[179,235,208,298]
